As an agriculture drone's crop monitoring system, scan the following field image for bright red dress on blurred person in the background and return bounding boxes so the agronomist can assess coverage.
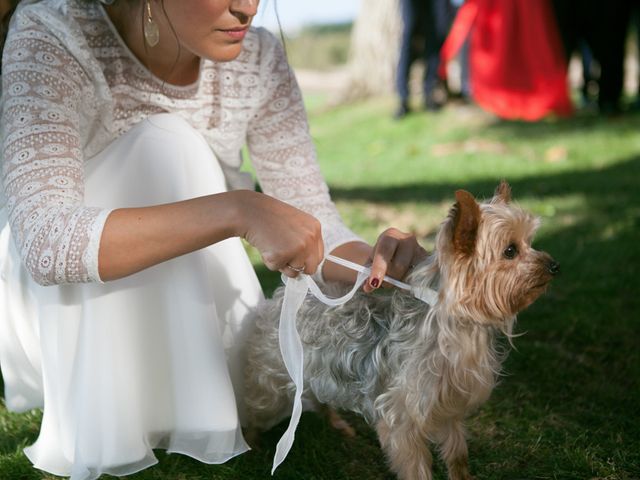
[440,0,573,121]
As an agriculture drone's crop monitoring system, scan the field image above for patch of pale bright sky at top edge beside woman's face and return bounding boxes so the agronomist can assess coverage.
[253,0,362,33]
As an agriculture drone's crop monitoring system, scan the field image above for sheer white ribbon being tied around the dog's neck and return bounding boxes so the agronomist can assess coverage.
[271,255,438,475]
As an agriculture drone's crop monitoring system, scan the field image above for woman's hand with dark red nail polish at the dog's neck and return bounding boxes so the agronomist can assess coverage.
[363,228,427,292]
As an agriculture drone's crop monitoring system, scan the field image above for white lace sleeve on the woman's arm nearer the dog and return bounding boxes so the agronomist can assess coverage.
[248,30,360,253]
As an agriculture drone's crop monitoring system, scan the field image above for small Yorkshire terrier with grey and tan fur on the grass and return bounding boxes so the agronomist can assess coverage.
[245,181,559,480]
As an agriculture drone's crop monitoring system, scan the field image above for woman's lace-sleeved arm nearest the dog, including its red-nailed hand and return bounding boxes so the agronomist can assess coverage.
[248,31,425,291]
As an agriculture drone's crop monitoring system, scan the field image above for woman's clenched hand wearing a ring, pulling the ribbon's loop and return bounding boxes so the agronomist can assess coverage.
[237,190,324,277]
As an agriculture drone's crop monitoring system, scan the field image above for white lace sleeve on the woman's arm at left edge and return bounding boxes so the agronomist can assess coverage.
[0,15,109,285]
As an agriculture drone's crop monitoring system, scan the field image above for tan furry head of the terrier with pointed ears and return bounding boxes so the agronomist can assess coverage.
[436,181,558,326]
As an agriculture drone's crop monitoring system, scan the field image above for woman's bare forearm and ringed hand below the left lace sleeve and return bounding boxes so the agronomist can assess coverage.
[99,190,323,280]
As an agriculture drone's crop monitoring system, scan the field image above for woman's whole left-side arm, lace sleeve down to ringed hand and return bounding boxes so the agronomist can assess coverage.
[0,12,323,285]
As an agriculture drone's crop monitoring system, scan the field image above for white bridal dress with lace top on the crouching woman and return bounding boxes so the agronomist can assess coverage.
[0,0,357,480]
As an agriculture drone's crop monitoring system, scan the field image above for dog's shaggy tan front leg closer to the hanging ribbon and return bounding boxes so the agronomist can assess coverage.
[376,418,433,480]
